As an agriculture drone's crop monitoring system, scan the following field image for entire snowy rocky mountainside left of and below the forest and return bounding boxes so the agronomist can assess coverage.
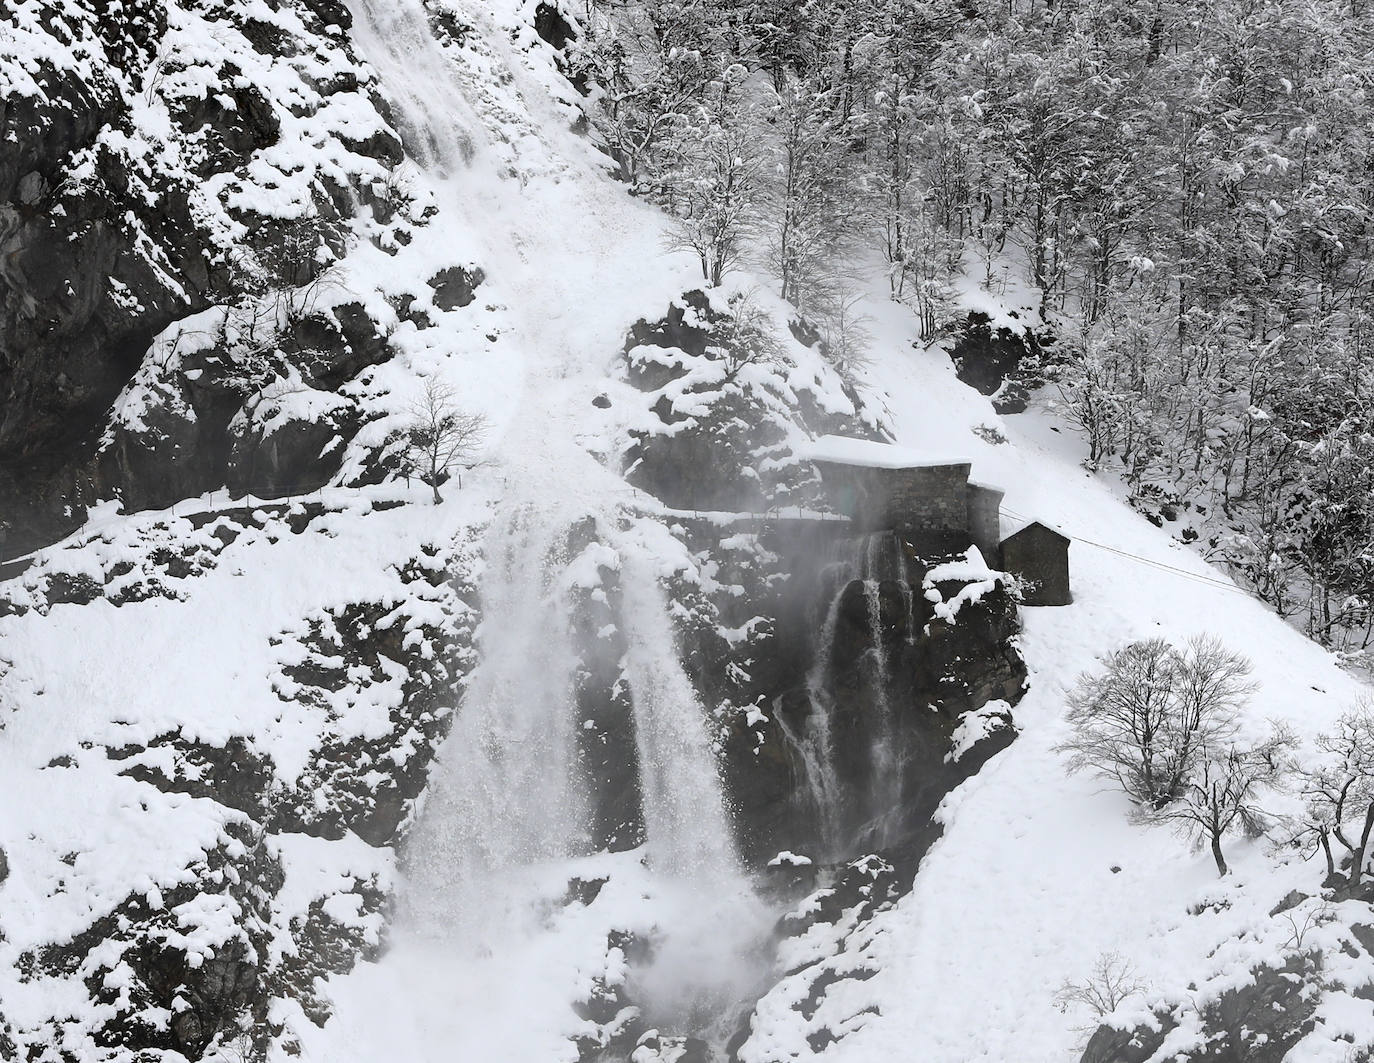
[0,0,1370,1063]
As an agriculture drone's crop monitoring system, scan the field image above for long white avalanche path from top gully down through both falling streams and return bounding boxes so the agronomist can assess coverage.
[306,0,767,1063]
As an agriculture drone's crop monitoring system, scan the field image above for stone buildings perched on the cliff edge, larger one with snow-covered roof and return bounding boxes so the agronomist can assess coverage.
[802,435,1073,606]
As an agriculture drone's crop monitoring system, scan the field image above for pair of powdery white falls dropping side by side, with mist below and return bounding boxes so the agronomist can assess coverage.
[398,504,776,1044]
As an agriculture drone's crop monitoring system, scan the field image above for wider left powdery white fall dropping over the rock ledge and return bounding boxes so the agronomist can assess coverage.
[408,505,588,948]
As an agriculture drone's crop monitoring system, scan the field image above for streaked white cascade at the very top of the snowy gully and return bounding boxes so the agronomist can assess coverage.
[349,0,475,176]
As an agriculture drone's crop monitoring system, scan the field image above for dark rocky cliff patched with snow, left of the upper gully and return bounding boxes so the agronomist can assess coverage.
[0,3,423,555]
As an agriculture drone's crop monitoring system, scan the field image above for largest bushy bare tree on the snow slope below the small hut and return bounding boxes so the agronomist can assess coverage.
[1059,636,1250,809]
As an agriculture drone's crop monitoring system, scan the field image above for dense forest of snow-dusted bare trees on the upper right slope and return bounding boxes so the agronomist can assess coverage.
[577,0,1374,652]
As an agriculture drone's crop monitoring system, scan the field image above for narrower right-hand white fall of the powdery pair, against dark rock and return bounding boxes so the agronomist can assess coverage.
[621,562,738,879]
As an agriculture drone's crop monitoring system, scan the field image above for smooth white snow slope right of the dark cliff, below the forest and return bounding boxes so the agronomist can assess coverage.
[742,293,1374,1063]
